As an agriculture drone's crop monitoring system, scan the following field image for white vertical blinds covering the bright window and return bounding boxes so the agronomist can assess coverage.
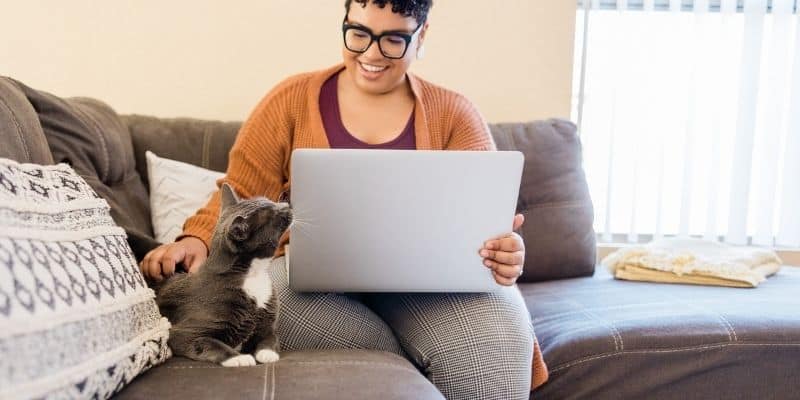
[576,0,800,247]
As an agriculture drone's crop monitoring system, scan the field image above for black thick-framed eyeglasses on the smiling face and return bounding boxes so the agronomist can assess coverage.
[342,17,425,59]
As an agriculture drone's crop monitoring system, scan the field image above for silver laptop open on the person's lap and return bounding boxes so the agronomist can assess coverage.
[287,149,523,292]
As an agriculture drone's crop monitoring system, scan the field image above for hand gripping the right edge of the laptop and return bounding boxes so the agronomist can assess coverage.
[479,214,525,286]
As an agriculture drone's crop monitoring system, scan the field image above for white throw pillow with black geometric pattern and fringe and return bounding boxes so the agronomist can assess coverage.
[0,158,170,399]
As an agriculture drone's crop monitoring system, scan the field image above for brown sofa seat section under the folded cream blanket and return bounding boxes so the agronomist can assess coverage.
[520,267,800,399]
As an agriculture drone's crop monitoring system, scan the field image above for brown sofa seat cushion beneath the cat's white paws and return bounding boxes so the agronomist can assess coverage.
[116,350,444,400]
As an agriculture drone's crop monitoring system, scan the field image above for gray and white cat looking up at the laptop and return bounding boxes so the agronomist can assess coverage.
[156,184,293,367]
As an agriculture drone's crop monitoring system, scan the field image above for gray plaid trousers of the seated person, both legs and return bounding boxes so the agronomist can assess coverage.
[270,257,533,399]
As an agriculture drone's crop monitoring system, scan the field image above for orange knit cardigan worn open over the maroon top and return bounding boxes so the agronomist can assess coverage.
[179,64,547,387]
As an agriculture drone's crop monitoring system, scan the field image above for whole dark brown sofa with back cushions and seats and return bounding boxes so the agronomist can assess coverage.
[0,77,800,399]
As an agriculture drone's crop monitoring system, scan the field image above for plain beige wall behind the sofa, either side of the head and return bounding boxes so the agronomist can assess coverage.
[0,0,575,122]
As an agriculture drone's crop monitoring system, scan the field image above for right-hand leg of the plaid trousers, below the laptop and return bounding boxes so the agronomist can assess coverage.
[371,287,533,399]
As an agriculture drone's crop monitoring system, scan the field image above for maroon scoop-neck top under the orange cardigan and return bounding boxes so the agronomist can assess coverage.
[319,74,417,150]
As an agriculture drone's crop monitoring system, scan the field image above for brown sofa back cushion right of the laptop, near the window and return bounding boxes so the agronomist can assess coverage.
[490,119,596,282]
